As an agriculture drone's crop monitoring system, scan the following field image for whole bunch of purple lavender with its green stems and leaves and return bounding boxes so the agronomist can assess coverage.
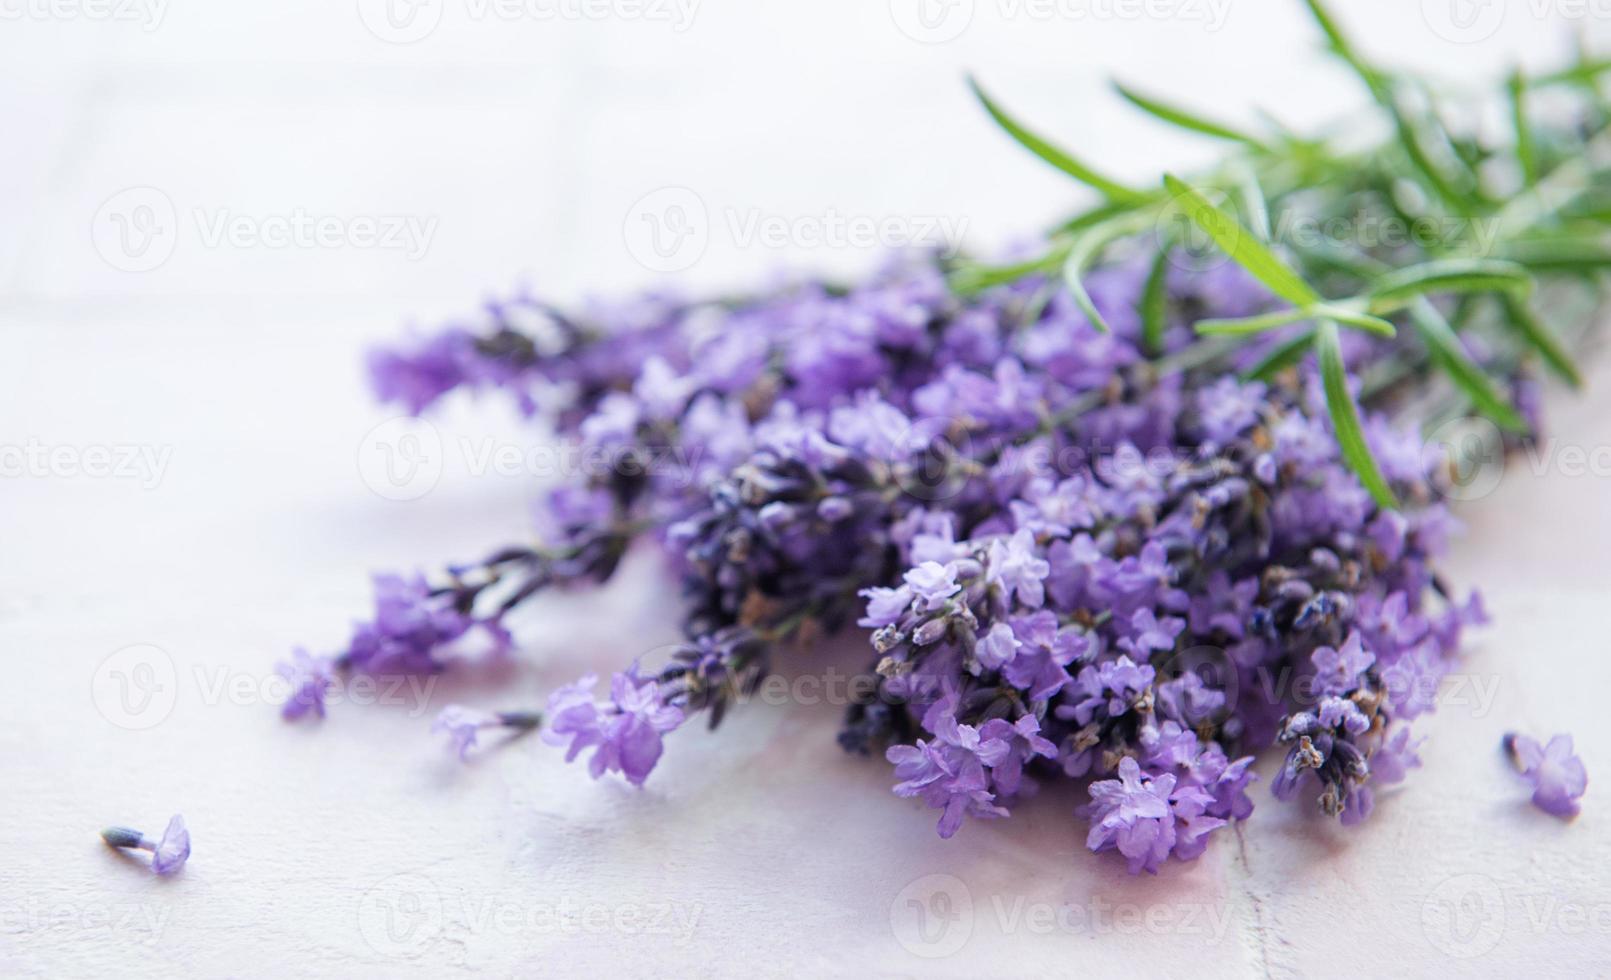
[287,2,1611,872]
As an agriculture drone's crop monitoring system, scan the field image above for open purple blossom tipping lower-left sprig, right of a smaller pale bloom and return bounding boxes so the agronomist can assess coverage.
[543,671,683,787]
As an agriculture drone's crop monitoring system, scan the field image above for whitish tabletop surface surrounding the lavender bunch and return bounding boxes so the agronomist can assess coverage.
[0,0,1611,977]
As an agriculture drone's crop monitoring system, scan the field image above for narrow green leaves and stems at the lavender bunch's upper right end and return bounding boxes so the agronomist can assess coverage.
[954,0,1611,508]
